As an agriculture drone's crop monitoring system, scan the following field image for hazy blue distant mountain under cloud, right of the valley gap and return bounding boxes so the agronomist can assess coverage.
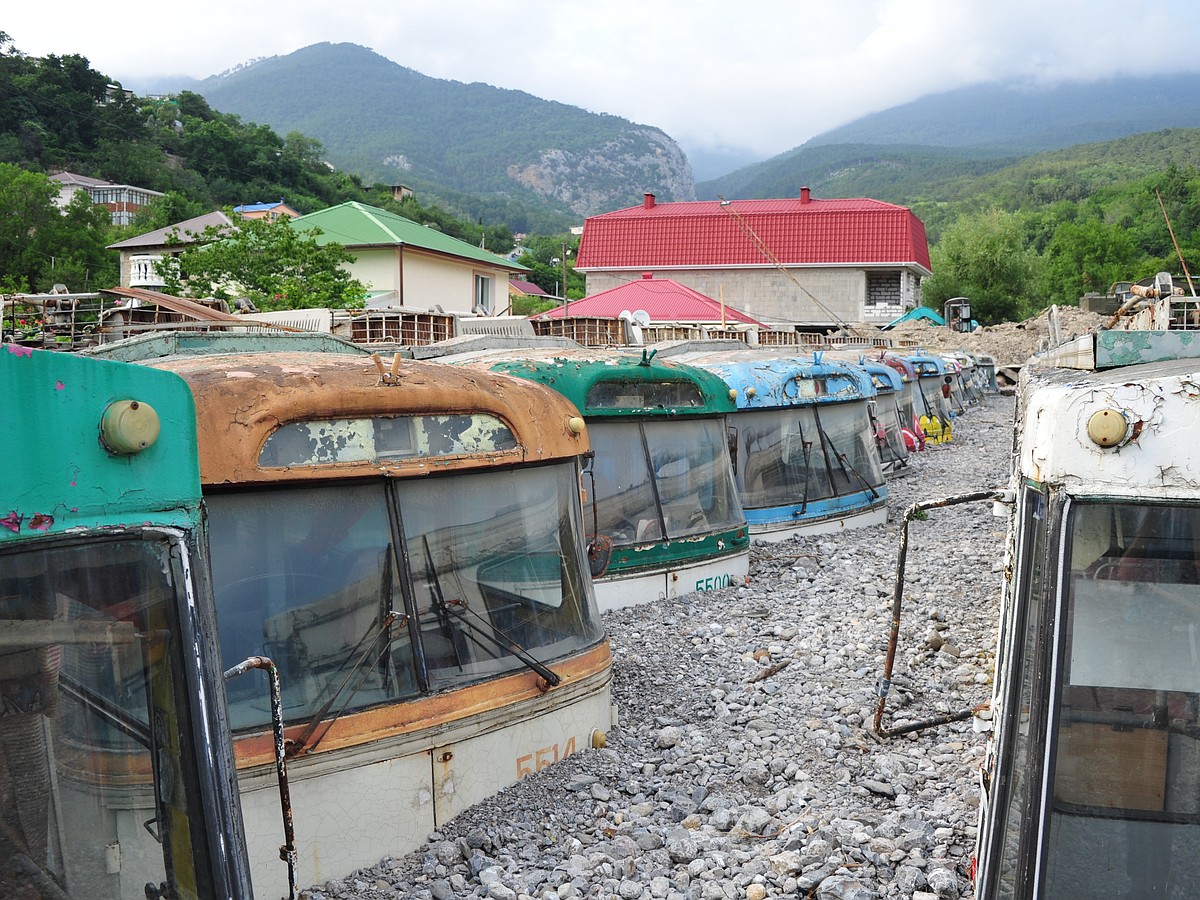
[696,74,1200,203]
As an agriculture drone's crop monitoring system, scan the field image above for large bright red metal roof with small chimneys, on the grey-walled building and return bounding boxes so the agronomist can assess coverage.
[576,188,929,271]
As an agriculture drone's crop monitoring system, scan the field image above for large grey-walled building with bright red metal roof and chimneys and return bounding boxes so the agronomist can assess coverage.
[571,187,931,324]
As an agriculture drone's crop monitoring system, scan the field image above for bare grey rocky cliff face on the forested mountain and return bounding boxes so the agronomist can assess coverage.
[508,127,696,216]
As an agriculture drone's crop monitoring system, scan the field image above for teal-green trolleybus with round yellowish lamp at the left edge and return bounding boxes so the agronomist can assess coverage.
[0,344,262,900]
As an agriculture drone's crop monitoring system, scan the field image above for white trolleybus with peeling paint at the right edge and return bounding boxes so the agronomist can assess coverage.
[977,294,1200,900]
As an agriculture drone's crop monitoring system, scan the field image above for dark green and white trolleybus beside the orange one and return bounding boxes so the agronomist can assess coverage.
[414,347,750,611]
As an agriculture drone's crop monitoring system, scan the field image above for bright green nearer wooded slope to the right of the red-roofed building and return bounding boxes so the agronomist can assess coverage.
[910,136,1200,322]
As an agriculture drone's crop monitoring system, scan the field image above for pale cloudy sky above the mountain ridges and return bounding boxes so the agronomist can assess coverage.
[0,0,1200,165]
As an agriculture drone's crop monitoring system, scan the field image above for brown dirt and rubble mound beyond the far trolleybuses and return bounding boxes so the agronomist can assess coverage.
[840,306,1109,366]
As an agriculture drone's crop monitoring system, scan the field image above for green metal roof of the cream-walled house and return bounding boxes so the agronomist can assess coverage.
[290,200,529,272]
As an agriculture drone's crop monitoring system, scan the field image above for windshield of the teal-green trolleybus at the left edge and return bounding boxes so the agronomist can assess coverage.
[0,530,215,898]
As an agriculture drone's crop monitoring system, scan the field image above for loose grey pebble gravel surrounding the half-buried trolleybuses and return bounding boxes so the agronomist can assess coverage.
[301,396,1013,900]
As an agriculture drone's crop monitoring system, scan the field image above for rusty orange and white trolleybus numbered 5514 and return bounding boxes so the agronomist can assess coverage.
[108,336,612,896]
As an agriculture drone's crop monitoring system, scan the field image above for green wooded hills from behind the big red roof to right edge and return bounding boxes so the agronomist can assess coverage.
[706,128,1200,323]
